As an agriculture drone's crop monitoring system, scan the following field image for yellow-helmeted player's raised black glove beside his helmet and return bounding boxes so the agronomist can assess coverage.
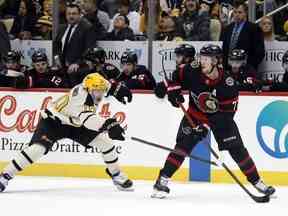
[107,83,132,104]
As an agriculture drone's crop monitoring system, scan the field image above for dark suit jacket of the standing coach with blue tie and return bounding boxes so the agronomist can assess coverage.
[221,21,265,70]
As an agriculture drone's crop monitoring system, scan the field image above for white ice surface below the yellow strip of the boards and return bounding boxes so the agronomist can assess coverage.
[0,177,288,216]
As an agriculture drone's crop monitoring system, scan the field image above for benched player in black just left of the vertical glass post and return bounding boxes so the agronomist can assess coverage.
[117,50,156,90]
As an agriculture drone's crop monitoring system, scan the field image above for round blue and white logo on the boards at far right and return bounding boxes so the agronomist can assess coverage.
[256,100,288,158]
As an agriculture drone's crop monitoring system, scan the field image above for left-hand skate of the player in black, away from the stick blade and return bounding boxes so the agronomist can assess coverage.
[151,174,170,199]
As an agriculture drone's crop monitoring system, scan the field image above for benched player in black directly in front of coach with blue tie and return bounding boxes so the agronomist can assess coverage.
[227,49,262,92]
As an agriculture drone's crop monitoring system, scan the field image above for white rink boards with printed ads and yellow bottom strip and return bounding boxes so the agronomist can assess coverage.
[0,89,288,185]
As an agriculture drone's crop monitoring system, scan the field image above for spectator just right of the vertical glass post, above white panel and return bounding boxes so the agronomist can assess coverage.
[155,14,183,41]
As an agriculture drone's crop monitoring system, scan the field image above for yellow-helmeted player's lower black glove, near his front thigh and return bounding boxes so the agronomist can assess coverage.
[99,118,125,141]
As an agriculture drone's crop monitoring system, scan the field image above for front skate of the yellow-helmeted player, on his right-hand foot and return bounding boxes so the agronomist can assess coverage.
[105,169,134,191]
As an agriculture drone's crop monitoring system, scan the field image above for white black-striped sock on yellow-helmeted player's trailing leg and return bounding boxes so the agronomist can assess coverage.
[12,144,46,171]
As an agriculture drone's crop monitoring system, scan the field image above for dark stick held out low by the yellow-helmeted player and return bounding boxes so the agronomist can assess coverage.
[130,136,218,166]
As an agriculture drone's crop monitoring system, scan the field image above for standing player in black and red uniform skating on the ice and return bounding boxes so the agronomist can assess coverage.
[152,45,275,198]
